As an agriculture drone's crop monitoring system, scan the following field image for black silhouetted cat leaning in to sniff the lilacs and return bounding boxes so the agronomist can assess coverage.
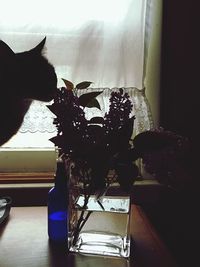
[0,37,57,146]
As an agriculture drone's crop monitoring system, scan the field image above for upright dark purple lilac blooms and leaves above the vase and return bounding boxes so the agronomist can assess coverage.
[48,80,138,193]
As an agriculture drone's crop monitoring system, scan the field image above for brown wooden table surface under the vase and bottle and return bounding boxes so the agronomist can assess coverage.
[0,205,177,267]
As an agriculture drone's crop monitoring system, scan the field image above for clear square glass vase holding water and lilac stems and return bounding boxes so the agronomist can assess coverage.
[68,190,131,258]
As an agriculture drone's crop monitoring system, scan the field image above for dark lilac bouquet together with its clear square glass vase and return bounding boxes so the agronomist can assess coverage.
[48,79,189,257]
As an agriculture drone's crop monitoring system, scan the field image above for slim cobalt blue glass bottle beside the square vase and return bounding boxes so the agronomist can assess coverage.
[48,158,68,243]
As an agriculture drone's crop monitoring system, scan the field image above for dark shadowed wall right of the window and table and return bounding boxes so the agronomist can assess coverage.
[150,0,200,267]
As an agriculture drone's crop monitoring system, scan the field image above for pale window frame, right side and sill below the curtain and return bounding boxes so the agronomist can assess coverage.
[0,1,162,186]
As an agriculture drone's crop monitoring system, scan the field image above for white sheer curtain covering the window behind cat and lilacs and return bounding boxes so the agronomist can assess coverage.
[0,0,153,149]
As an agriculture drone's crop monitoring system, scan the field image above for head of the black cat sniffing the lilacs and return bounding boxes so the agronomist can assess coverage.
[0,38,57,101]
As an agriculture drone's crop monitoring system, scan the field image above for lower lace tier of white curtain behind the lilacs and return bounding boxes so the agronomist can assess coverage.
[20,87,153,134]
